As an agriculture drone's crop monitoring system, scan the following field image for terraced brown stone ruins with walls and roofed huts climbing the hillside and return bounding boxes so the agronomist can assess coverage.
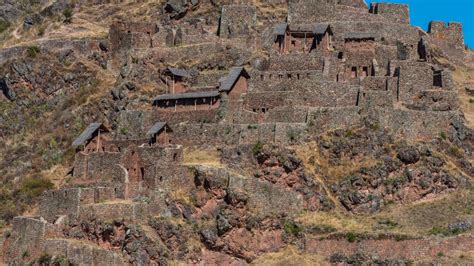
[4,0,470,265]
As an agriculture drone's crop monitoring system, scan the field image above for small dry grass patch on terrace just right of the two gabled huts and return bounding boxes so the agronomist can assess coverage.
[183,147,222,167]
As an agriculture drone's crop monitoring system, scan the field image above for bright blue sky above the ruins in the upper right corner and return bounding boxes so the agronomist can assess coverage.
[365,0,474,49]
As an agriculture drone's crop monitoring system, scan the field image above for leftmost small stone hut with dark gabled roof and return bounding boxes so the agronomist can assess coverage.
[72,123,111,153]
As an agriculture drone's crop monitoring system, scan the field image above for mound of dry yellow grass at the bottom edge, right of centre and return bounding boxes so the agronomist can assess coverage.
[251,246,330,266]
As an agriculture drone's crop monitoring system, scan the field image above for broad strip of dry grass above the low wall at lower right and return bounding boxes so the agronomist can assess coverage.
[295,187,474,237]
